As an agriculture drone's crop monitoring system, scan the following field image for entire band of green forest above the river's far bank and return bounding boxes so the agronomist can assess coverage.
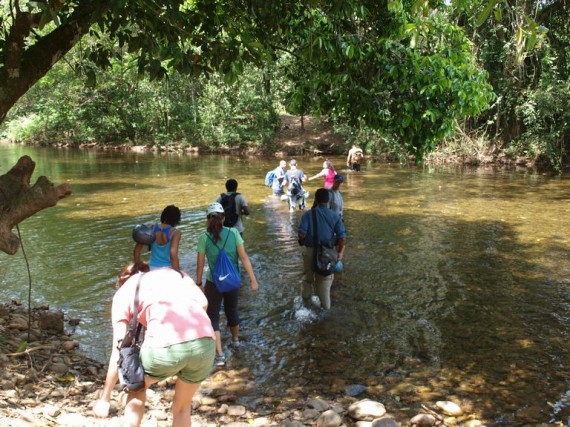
[0,0,570,171]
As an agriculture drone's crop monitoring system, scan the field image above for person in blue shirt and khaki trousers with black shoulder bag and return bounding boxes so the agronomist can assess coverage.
[297,188,346,310]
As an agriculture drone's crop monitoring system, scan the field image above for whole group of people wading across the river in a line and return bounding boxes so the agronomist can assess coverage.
[93,149,359,426]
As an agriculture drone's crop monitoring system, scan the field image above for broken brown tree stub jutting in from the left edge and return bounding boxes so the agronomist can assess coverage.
[0,156,71,255]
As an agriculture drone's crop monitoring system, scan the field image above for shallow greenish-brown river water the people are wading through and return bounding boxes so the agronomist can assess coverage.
[0,145,570,425]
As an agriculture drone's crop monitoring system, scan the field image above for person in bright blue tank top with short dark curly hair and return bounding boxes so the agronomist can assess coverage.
[133,205,181,271]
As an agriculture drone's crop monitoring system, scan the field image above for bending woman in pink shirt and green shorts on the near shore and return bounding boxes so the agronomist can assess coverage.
[93,264,216,426]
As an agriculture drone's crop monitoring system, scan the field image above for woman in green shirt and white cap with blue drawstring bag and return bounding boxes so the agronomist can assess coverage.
[196,202,259,366]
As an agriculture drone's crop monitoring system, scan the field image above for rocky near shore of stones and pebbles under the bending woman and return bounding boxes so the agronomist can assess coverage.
[0,302,483,427]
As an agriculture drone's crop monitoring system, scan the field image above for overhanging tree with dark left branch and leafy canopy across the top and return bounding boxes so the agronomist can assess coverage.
[0,0,492,159]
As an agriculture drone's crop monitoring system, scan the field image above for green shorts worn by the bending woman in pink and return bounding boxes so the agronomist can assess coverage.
[140,337,216,384]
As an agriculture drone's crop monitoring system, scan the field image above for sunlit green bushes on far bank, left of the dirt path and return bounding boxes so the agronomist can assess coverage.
[3,45,277,149]
